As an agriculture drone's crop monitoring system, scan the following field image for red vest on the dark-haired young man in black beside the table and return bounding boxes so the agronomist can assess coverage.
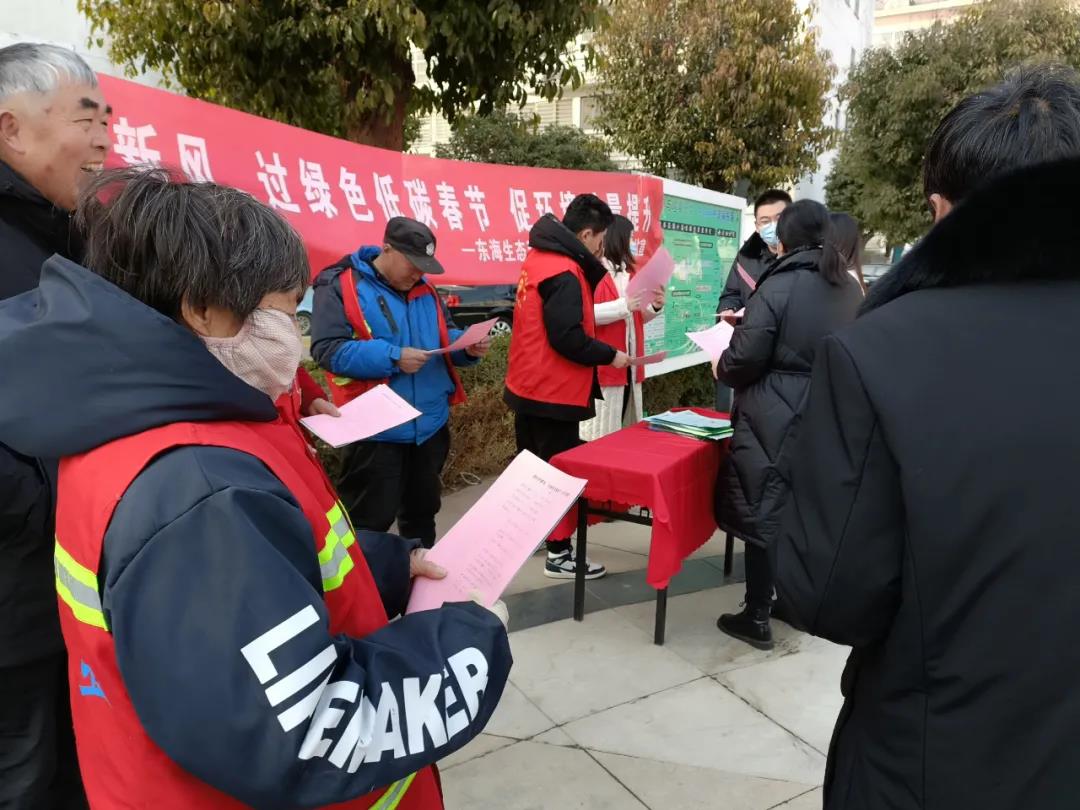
[507,248,596,407]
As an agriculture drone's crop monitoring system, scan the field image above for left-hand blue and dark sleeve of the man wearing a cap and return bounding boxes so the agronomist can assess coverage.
[311,268,402,380]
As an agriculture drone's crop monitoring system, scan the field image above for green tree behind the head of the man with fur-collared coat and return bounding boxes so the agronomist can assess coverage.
[827,0,1080,244]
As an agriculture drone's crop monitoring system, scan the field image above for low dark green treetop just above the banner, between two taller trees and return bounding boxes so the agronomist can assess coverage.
[435,110,617,172]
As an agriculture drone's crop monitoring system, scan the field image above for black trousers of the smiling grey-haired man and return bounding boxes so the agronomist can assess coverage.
[0,653,87,810]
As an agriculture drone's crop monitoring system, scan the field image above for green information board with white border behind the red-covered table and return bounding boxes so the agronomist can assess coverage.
[645,181,742,376]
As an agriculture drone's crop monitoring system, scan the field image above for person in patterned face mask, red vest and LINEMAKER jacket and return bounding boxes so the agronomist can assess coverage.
[0,170,511,810]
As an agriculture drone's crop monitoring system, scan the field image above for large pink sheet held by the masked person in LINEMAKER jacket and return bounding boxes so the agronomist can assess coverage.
[406,450,585,613]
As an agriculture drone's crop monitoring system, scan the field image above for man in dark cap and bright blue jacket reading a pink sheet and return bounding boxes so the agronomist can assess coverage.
[311,217,489,548]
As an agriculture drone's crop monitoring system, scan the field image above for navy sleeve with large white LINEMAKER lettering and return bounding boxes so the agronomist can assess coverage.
[103,448,511,810]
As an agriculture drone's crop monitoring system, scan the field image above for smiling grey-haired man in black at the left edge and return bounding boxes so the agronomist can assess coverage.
[0,44,109,810]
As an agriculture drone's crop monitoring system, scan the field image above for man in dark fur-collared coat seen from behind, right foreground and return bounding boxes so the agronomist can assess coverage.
[777,68,1080,810]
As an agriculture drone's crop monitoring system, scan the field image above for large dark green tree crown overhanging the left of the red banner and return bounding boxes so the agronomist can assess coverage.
[78,0,604,149]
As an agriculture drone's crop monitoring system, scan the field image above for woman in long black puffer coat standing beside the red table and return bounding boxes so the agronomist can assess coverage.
[716,200,863,649]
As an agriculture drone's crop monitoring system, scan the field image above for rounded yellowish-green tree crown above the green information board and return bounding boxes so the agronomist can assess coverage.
[596,0,834,191]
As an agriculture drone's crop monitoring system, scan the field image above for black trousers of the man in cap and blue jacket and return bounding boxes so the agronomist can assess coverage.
[337,424,450,549]
